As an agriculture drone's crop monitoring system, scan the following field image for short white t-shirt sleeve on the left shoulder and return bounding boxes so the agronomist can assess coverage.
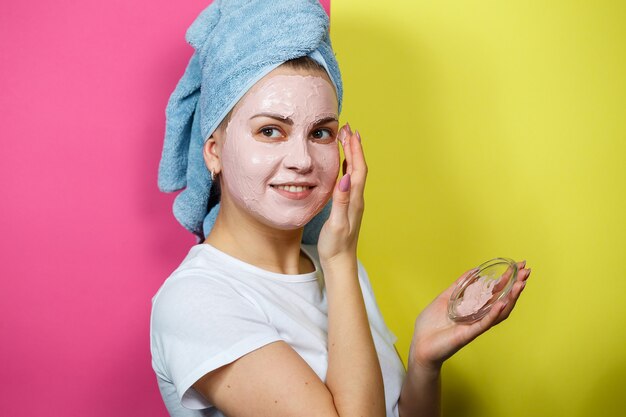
[152,276,282,409]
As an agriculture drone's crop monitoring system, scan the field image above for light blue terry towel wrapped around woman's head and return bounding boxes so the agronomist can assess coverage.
[158,0,343,243]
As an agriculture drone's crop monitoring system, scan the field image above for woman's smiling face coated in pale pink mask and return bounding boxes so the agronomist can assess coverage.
[221,68,339,230]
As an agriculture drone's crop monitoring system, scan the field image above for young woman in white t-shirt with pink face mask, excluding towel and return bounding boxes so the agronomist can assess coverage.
[151,0,529,417]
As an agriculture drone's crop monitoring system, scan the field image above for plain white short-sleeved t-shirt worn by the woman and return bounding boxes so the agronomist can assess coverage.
[150,243,405,417]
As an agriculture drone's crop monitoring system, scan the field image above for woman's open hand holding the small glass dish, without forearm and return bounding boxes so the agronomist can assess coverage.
[409,262,530,370]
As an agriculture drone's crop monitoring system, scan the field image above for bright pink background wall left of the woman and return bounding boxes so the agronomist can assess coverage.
[0,0,329,417]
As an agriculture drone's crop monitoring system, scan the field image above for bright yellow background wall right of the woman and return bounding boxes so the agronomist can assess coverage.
[331,0,626,417]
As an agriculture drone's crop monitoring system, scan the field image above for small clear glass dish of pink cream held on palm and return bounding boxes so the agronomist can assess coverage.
[448,258,518,323]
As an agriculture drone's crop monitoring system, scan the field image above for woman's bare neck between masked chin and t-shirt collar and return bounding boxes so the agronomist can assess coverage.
[205,195,315,274]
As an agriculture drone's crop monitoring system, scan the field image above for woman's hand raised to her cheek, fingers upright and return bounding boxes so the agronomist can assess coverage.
[317,124,367,267]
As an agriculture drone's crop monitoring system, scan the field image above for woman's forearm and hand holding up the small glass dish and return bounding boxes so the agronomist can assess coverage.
[398,262,530,417]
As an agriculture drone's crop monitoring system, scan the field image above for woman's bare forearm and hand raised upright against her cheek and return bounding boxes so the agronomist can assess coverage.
[318,126,385,417]
